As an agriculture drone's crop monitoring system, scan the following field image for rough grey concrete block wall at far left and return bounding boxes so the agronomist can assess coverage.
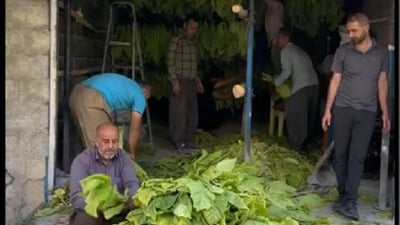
[6,0,50,225]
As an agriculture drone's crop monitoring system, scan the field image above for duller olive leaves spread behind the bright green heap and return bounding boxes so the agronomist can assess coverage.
[144,137,314,188]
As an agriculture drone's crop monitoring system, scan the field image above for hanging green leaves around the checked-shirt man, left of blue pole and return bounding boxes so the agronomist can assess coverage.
[111,0,247,109]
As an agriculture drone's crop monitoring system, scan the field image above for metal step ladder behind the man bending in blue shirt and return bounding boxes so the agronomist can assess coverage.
[101,2,153,150]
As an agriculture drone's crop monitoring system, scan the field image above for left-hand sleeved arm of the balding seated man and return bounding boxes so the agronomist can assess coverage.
[70,158,88,210]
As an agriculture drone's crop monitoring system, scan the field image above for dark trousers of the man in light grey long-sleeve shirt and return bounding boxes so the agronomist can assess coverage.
[286,85,319,149]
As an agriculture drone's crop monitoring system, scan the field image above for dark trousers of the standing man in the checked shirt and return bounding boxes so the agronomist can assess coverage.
[169,79,199,145]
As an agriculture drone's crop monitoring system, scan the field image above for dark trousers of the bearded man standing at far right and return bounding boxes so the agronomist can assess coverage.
[333,106,376,203]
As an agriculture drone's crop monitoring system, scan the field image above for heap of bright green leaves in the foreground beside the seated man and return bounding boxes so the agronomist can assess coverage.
[113,151,330,225]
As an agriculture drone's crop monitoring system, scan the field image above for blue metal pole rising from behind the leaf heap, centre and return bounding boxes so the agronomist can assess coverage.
[244,0,254,162]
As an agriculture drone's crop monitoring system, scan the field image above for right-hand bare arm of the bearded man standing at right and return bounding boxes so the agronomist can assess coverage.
[378,72,390,132]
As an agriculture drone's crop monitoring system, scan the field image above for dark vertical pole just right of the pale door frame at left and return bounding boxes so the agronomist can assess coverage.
[63,0,71,170]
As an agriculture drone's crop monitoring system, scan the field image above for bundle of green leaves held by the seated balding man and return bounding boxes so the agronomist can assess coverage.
[80,174,128,219]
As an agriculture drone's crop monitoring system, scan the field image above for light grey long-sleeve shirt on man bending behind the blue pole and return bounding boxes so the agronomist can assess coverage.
[274,42,319,95]
